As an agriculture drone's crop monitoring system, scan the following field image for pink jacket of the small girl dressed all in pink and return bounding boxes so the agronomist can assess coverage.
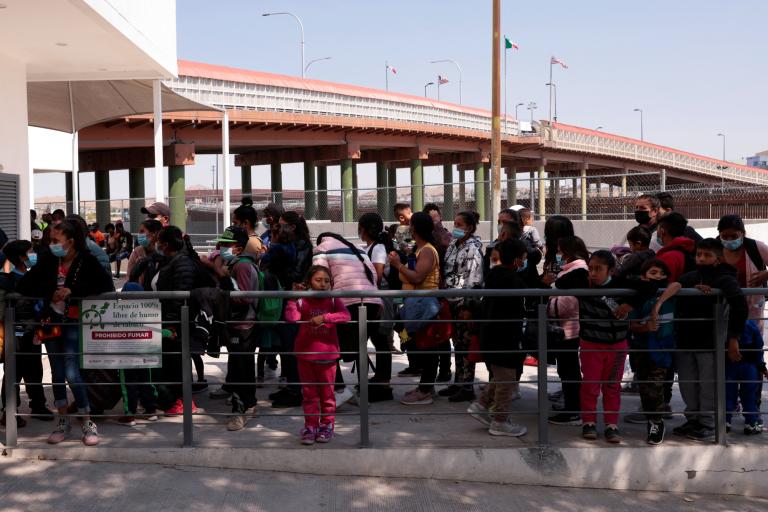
[285,298,351,361]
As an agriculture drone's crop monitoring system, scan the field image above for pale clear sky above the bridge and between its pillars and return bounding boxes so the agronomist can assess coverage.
[38,0,768,203]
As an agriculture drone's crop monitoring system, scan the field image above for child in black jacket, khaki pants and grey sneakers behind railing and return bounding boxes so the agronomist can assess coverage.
[467,238,527,437]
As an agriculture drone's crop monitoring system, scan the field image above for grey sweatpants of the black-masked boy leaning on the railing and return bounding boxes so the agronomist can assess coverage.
[675,352,715,428]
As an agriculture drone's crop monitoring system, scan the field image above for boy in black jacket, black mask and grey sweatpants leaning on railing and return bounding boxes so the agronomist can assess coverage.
[651,238,747,442]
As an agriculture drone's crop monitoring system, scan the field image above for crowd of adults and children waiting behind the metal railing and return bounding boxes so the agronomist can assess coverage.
[0,193,768,445]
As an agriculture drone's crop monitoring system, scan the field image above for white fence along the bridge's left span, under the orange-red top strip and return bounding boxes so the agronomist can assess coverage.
[165,76,520,135]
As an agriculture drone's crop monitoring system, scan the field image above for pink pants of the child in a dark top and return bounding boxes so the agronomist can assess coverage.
[579,340,627,425]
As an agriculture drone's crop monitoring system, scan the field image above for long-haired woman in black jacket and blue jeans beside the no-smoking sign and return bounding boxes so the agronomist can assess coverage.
[18,220,115,446]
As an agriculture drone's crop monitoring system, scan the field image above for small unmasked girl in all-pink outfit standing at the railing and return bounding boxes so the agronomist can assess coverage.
[285,265,350,445]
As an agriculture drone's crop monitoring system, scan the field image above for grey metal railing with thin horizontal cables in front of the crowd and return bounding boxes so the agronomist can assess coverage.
[4,289,768,448]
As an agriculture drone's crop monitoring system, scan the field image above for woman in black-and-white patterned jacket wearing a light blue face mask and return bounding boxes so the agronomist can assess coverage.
[438,211,483,402]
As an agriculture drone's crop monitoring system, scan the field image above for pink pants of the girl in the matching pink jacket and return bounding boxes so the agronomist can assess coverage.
[298,359,336,428]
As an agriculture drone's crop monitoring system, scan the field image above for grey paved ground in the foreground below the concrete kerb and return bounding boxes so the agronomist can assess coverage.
[0,459,768,512]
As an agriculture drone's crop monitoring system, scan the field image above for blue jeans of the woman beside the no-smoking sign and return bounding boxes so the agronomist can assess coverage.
[45,324,91,413]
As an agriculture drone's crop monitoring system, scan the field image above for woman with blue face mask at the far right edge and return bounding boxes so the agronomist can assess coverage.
[717,214,768,330]
